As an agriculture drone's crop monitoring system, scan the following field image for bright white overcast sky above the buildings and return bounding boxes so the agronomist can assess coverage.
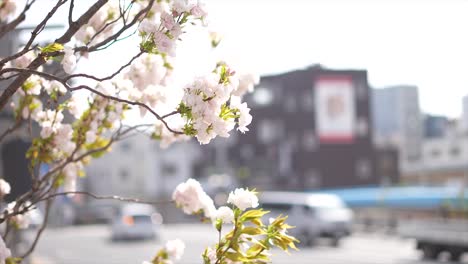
[20,0,468,117]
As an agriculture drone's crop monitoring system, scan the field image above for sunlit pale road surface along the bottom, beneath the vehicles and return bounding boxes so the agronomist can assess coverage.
[30,224,468,264]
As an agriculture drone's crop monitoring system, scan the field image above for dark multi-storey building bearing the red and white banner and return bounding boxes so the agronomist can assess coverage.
[194,67,398,190]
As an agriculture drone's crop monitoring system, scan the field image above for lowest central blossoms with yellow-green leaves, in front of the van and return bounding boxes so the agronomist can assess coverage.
[171,179,298,264]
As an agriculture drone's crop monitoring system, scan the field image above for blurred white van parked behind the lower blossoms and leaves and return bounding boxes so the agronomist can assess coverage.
[260,192,353,246]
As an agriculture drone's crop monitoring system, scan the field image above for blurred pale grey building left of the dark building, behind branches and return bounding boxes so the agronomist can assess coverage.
[83,134,198,199]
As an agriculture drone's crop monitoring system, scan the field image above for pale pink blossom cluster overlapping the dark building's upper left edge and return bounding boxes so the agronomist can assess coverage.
[178,63,257,144]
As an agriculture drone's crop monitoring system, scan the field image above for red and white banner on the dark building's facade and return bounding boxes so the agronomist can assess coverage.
[315,75,356,144]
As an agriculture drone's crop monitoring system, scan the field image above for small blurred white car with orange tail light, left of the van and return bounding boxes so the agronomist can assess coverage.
[111,204,162,241]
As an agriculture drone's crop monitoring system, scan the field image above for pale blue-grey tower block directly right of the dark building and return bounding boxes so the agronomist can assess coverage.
[372,85,423,173]
